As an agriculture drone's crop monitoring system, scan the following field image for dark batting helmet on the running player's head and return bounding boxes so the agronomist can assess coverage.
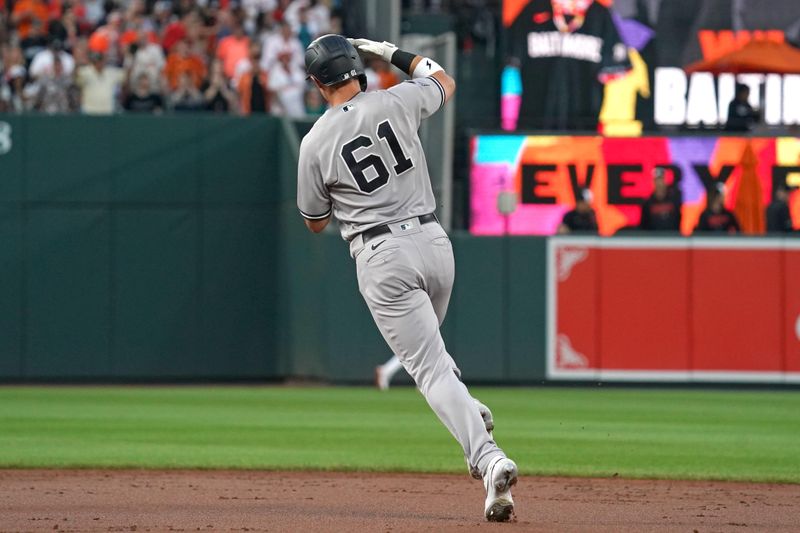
[306,34,367,91]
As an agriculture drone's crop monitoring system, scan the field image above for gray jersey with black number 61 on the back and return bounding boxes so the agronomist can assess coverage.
[297,78,444,241]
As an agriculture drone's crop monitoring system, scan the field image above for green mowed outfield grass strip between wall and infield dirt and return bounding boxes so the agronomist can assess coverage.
[0,387,800,483]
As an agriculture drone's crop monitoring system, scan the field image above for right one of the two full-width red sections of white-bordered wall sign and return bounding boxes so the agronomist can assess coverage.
[691,249,783,372]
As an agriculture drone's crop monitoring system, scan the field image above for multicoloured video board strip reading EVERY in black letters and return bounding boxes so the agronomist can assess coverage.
[470,135,800,235]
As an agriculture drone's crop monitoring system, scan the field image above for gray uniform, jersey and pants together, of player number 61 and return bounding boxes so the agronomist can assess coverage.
[297,71,504,474]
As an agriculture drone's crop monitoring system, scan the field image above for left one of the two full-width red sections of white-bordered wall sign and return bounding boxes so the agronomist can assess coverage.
[598,248,689,371]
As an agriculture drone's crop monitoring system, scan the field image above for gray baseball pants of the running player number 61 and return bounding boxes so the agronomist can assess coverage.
[350,218,505,475]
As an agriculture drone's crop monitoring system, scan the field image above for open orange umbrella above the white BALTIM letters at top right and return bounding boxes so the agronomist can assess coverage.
[686,40,800,74]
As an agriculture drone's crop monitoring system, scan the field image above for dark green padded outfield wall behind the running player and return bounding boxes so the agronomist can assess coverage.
[0,115,546,382]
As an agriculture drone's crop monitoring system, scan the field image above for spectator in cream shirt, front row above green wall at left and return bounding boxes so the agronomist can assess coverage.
[75,52,125,115]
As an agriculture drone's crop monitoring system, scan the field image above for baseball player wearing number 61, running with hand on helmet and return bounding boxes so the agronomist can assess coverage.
[297,35,517,521]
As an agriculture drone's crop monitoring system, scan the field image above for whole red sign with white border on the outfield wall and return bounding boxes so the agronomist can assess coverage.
[547,237,800,383]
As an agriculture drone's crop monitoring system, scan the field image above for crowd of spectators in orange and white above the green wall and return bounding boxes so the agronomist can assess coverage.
[0,0,399,117]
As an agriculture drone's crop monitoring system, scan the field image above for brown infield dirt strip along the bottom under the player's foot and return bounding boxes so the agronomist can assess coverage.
[0,470,800,533]
